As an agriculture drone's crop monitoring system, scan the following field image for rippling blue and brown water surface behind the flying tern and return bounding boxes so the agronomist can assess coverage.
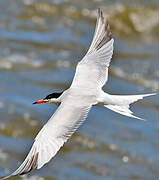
[0,0,159,180]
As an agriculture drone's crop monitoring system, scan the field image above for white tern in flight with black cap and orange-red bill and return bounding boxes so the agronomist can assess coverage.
[0,9,155,179]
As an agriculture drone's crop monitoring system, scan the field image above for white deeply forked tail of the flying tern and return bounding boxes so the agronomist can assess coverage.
[104,93,156,120]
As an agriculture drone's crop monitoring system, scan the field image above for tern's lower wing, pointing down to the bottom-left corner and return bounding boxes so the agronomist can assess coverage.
[4,97,91,179]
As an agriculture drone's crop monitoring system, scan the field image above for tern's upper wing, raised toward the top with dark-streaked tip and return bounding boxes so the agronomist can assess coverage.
[71,9,114,89]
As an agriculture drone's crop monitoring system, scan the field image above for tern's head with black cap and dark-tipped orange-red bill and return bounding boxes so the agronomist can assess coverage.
[33,92,63,104]
